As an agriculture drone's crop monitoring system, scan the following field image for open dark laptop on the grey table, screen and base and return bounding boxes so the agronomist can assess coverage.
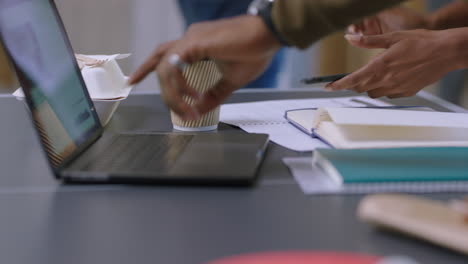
[0,0,268,185]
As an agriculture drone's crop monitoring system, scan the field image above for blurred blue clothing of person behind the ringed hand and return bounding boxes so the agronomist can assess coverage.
[178,0,285,88]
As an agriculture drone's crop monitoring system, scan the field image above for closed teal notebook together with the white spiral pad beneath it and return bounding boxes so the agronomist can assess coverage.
[283,147,468,194]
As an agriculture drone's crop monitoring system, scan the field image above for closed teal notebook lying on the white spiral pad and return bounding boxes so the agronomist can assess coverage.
[314,147,468,183]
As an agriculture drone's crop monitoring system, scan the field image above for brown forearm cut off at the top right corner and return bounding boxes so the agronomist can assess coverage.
[428,1,468,30]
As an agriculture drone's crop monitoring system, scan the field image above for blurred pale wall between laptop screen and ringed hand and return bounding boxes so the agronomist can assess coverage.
[56,0,183,90]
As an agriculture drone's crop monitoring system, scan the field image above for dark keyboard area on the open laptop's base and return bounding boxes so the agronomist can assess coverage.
[85,134,193,172]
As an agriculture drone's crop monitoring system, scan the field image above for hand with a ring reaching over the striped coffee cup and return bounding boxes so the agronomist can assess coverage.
[129,15,281,120]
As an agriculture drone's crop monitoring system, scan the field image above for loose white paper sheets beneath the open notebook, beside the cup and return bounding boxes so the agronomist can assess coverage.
[220,96,389,151]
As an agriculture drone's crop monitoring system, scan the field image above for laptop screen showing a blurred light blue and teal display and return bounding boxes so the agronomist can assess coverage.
[0,0,102,169]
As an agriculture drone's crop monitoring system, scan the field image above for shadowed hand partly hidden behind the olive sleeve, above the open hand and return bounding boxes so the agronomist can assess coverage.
[348,7,430,35]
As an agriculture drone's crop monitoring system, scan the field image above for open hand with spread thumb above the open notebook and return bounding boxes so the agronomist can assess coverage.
[326,29,467,98]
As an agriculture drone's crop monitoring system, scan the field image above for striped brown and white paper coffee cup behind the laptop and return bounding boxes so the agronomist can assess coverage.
[171,60,222,132]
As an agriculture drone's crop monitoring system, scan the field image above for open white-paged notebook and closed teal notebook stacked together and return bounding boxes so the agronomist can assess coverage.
[286,108,468,193]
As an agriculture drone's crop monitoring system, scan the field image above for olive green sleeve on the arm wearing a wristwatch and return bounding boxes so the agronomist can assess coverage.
[271,0,403,49]
